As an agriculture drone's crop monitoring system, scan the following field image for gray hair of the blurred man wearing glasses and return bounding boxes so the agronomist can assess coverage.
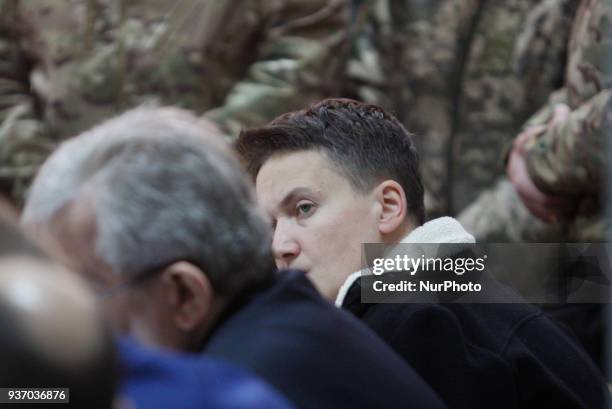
[22,108,273,294]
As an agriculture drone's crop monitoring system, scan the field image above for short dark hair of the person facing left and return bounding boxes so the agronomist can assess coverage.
[236,98,425,224]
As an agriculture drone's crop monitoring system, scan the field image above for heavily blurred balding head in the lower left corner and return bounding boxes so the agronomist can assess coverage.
[0,196,116,409]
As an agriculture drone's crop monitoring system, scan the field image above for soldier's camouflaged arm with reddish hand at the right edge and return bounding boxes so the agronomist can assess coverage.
[507,0,612,242]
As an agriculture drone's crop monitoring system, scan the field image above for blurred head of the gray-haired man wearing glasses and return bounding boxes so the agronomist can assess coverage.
[22,108,272,350]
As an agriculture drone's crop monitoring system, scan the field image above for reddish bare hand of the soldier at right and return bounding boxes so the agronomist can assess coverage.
[506,127,572,223]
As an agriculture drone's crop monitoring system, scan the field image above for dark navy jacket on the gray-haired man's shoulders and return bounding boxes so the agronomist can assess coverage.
[203,271,445,409]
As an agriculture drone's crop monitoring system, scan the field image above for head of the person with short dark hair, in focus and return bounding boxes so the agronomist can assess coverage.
[237,99,425,297]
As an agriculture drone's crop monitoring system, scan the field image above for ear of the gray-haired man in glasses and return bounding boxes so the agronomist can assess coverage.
[161,261,215,332]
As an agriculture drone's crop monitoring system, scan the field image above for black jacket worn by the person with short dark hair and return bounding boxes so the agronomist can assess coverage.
[342,270,606,409]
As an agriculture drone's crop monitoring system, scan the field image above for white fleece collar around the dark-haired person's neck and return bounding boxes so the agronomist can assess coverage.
[334,216,476,308]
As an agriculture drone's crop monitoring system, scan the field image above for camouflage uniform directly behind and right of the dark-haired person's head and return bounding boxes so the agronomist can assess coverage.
[349,0,577,217]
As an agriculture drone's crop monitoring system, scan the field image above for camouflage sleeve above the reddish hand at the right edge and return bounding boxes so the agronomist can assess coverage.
[526,0,612,195]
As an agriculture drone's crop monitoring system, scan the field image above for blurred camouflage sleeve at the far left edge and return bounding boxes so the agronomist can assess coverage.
[0,0,49,202]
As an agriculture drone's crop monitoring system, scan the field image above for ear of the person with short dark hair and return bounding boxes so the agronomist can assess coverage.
[375,180,407,237]
